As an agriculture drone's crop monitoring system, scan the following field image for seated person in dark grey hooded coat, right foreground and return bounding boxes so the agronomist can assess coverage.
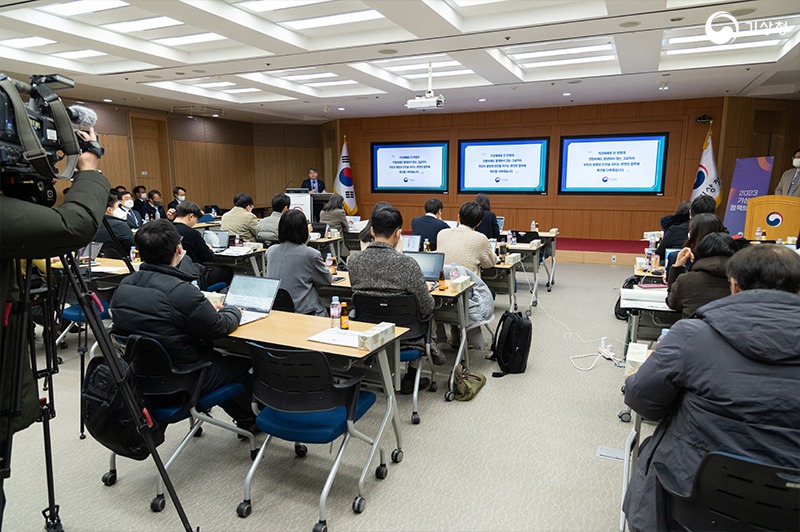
[623,244,800,532]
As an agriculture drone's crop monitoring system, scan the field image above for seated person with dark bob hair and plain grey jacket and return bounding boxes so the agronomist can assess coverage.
[267,210,331,316]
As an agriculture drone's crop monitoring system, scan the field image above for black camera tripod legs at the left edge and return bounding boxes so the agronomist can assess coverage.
[0,237,199,532]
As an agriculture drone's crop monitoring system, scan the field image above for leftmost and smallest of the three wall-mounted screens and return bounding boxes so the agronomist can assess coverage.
[372,141,448,192]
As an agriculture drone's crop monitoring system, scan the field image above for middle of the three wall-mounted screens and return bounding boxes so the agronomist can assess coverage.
[458,138,549,194]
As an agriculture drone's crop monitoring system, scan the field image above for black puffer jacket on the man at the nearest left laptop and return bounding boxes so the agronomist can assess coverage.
[111,263,241,364]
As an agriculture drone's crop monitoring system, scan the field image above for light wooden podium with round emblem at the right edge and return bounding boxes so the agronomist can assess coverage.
[744,196,800,242]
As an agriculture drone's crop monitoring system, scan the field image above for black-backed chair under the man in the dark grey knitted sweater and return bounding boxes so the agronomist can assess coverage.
[353,292,437,425]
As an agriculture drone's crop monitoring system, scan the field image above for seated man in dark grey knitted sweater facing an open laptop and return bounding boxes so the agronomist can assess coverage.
[350,206,446,394]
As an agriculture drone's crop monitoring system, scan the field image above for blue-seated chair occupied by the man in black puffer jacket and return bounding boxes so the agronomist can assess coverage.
[103,335,258,512]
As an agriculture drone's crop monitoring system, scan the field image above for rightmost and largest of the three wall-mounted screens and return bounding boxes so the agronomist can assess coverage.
[558,133,669,195]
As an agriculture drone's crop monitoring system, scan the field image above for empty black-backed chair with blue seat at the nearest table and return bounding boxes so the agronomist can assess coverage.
[236,343,388,532]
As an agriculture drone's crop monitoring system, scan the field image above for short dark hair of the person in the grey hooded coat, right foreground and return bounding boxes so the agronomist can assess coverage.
[725,244,800,294]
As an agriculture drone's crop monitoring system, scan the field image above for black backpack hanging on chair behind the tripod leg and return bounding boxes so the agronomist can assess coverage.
[81,357,164,460]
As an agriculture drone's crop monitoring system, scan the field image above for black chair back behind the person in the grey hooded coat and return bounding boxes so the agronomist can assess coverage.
[653,452,800,532]
